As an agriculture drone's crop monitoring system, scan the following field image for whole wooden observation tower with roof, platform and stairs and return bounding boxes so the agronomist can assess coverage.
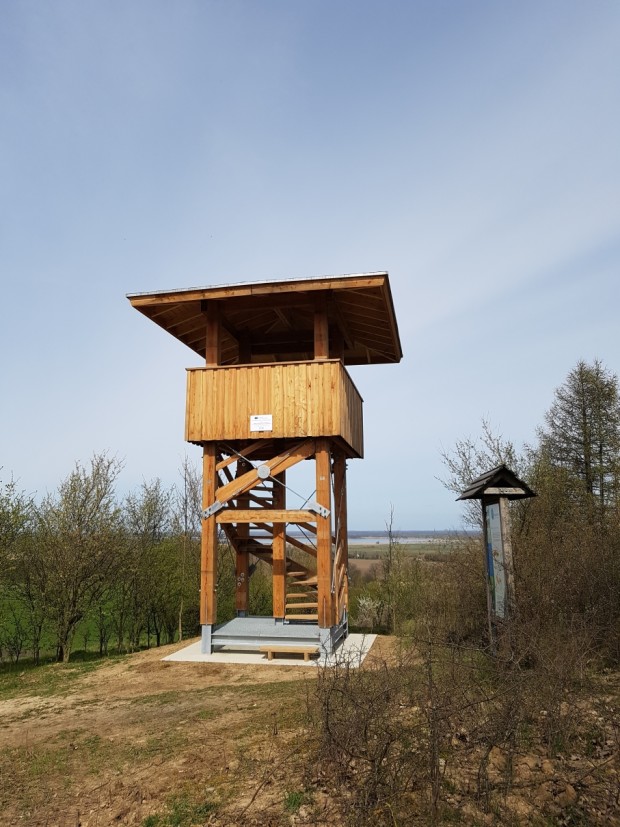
[128,273,402,652]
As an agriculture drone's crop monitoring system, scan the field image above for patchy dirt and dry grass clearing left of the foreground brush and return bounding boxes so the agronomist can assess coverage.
[0,642,392,827]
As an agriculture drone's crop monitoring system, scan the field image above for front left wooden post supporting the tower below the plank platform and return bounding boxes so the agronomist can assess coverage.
[200,442,217,626]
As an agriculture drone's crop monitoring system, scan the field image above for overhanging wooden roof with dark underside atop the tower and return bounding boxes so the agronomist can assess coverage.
[127,273,402,365]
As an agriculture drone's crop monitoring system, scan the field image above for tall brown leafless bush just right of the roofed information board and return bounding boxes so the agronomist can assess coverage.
[513,472,620,680]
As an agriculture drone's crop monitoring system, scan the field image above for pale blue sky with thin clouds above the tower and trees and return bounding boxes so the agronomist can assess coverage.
[0,0,620,529]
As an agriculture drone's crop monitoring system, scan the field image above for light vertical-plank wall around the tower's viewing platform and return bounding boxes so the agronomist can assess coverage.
[185,359,363,456]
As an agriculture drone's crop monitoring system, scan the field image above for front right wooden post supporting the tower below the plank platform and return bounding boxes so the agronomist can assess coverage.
[315,437,333,629]
